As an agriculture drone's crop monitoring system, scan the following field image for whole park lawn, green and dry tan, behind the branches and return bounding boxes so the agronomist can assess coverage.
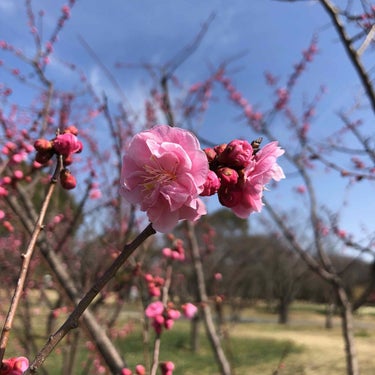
[7,302,375,375]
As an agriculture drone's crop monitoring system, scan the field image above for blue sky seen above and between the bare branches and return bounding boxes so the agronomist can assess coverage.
[0,0,375,244]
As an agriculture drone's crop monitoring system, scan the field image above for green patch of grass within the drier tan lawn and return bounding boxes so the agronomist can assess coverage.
[116,321,302,375]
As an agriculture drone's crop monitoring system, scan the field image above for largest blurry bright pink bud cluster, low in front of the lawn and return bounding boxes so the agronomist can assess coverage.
[145,301,181,335]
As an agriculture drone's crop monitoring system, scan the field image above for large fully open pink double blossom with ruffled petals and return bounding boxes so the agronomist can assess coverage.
[121,125,208,233]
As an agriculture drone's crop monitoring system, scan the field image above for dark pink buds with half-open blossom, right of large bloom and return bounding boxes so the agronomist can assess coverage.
[201,138,285,219]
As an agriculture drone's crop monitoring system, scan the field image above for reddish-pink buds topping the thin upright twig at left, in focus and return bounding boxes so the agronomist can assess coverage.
[34,126,82,190]
